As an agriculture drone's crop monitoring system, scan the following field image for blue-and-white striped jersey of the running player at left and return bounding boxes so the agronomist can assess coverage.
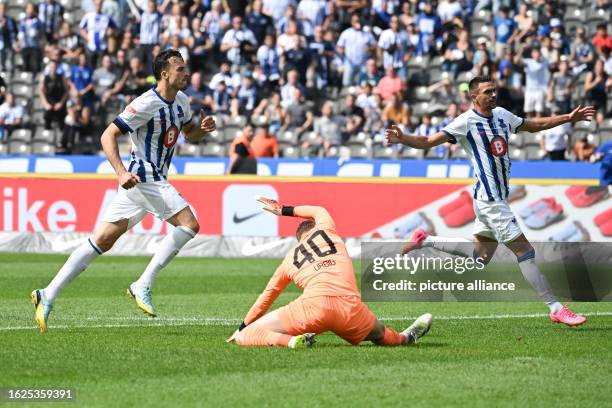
[113,88,192,183]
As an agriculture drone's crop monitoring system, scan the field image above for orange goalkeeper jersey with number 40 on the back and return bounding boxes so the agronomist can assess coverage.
[244,211,360,324]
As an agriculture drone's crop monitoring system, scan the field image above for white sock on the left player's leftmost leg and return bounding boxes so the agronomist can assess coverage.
[44,238,102,302]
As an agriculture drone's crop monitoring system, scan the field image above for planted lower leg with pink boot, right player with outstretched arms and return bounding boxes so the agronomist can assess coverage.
[506,234,586,326]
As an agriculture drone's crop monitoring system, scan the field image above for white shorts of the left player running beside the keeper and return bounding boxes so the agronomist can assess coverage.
[102,180,189,228]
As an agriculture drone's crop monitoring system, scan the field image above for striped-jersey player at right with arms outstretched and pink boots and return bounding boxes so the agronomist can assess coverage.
[385,77,595,326]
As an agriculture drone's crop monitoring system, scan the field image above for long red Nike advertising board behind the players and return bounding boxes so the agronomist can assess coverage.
[0,173,612,256]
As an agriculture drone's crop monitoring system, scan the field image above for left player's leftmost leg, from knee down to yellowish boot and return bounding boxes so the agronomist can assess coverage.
[30,220,128,332]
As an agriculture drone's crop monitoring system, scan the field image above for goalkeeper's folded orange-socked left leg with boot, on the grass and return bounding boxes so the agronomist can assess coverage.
[228,310,315,349]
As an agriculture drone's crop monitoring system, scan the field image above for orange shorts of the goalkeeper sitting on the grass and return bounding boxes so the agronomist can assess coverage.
[278,296,376,345]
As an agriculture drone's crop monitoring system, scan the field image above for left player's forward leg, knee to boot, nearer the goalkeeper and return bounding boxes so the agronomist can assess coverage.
[127,207,200,317]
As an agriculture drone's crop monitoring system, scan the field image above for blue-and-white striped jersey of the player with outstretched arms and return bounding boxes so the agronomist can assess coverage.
[442,107,524,201]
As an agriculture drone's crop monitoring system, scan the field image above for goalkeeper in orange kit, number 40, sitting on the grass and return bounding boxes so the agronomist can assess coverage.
[227,197,432,349]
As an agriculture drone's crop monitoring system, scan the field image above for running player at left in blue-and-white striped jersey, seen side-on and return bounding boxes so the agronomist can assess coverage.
[31,50,215,332]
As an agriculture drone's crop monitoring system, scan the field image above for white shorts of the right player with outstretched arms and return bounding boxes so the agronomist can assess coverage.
[474,200,523,244]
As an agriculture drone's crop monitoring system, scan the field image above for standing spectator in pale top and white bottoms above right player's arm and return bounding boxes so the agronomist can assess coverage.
[515,47,550,118]
